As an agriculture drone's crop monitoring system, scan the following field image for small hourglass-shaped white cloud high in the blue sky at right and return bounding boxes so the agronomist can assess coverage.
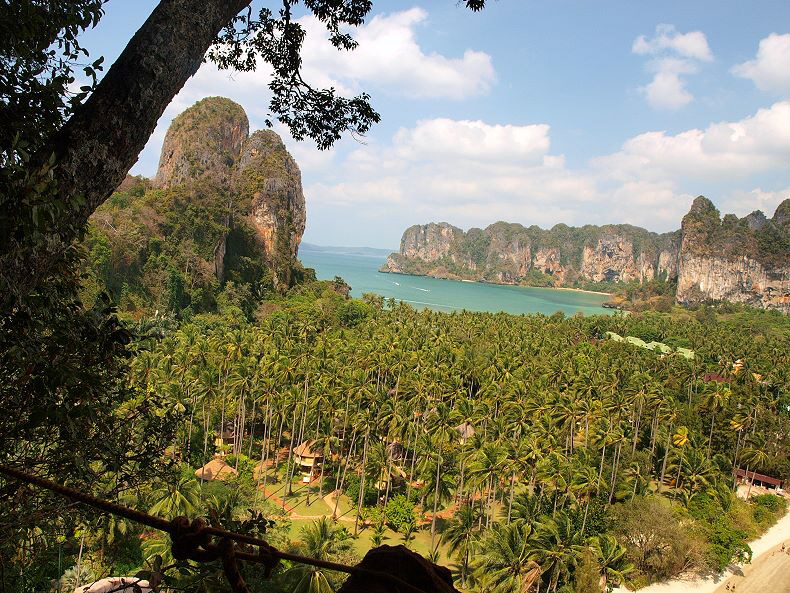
[631,24,713,110]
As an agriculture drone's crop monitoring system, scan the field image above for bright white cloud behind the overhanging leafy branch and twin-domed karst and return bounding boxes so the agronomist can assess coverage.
[132,8,496,175]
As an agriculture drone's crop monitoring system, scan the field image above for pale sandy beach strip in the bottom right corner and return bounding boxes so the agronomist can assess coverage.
[614,513,790,593]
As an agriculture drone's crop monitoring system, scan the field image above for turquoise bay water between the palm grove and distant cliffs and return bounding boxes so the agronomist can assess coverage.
[299,249,612,315]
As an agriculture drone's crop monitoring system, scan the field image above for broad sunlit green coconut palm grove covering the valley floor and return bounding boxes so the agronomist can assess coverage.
[7,282,790,592]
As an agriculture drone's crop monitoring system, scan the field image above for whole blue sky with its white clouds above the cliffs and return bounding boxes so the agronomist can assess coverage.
[83,0,790,248]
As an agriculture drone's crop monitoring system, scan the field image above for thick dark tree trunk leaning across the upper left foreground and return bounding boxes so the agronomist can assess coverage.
[6,0,250,297]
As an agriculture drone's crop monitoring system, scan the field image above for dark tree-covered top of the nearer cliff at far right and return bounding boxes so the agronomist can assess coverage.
[681,196,790,267]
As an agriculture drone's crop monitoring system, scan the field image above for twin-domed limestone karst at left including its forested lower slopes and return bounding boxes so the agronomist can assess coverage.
[86,97,305,315]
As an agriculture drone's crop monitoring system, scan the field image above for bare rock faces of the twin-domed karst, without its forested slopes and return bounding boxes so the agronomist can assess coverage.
[154,97,306,287]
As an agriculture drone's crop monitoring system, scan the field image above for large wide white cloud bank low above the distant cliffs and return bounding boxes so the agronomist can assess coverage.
[307,102,790,237]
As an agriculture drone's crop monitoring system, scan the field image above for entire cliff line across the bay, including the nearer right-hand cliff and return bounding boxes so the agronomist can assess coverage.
[381,196,790,312]
